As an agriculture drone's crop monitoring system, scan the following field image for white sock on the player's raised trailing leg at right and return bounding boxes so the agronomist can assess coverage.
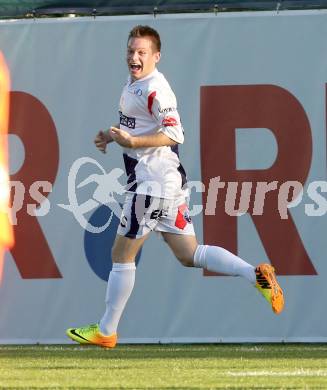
[194,245,256,284]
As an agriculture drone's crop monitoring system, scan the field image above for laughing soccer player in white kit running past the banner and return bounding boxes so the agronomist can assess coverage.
[67,26,284,348]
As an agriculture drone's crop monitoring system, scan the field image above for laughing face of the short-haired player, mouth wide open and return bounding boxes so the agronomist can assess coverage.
[127,37,160,81]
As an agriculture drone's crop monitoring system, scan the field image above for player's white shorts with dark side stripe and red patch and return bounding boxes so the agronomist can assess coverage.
[117,193,195,238]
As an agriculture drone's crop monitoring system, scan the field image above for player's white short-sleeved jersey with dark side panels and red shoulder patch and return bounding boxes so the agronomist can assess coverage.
[119,69,186,199]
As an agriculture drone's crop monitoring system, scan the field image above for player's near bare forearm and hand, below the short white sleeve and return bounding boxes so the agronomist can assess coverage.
[110,127,177,149]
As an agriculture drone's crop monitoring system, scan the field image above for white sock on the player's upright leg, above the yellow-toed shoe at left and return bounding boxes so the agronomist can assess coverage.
[99,263,136,335]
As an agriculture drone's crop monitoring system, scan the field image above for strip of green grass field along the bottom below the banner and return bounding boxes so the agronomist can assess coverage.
[0,344,327,389]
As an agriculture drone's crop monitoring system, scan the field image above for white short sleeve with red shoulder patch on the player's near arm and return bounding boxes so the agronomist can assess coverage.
[148,91,184,144]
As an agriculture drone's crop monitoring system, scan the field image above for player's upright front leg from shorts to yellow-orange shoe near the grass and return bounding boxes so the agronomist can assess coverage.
[67,194,150,348]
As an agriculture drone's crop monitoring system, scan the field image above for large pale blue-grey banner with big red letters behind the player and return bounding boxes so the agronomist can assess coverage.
[0,11,327,343]
